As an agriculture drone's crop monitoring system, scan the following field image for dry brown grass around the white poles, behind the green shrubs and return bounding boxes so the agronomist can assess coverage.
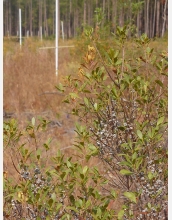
[3,39,82,179]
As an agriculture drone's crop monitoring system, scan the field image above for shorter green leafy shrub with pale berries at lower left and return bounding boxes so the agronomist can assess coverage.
[3,118,117,220]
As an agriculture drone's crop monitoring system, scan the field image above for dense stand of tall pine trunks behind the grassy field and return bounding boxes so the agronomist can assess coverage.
[3,0,168,39]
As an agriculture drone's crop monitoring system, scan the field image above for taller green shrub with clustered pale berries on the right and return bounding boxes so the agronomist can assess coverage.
[57,26,168,220]
